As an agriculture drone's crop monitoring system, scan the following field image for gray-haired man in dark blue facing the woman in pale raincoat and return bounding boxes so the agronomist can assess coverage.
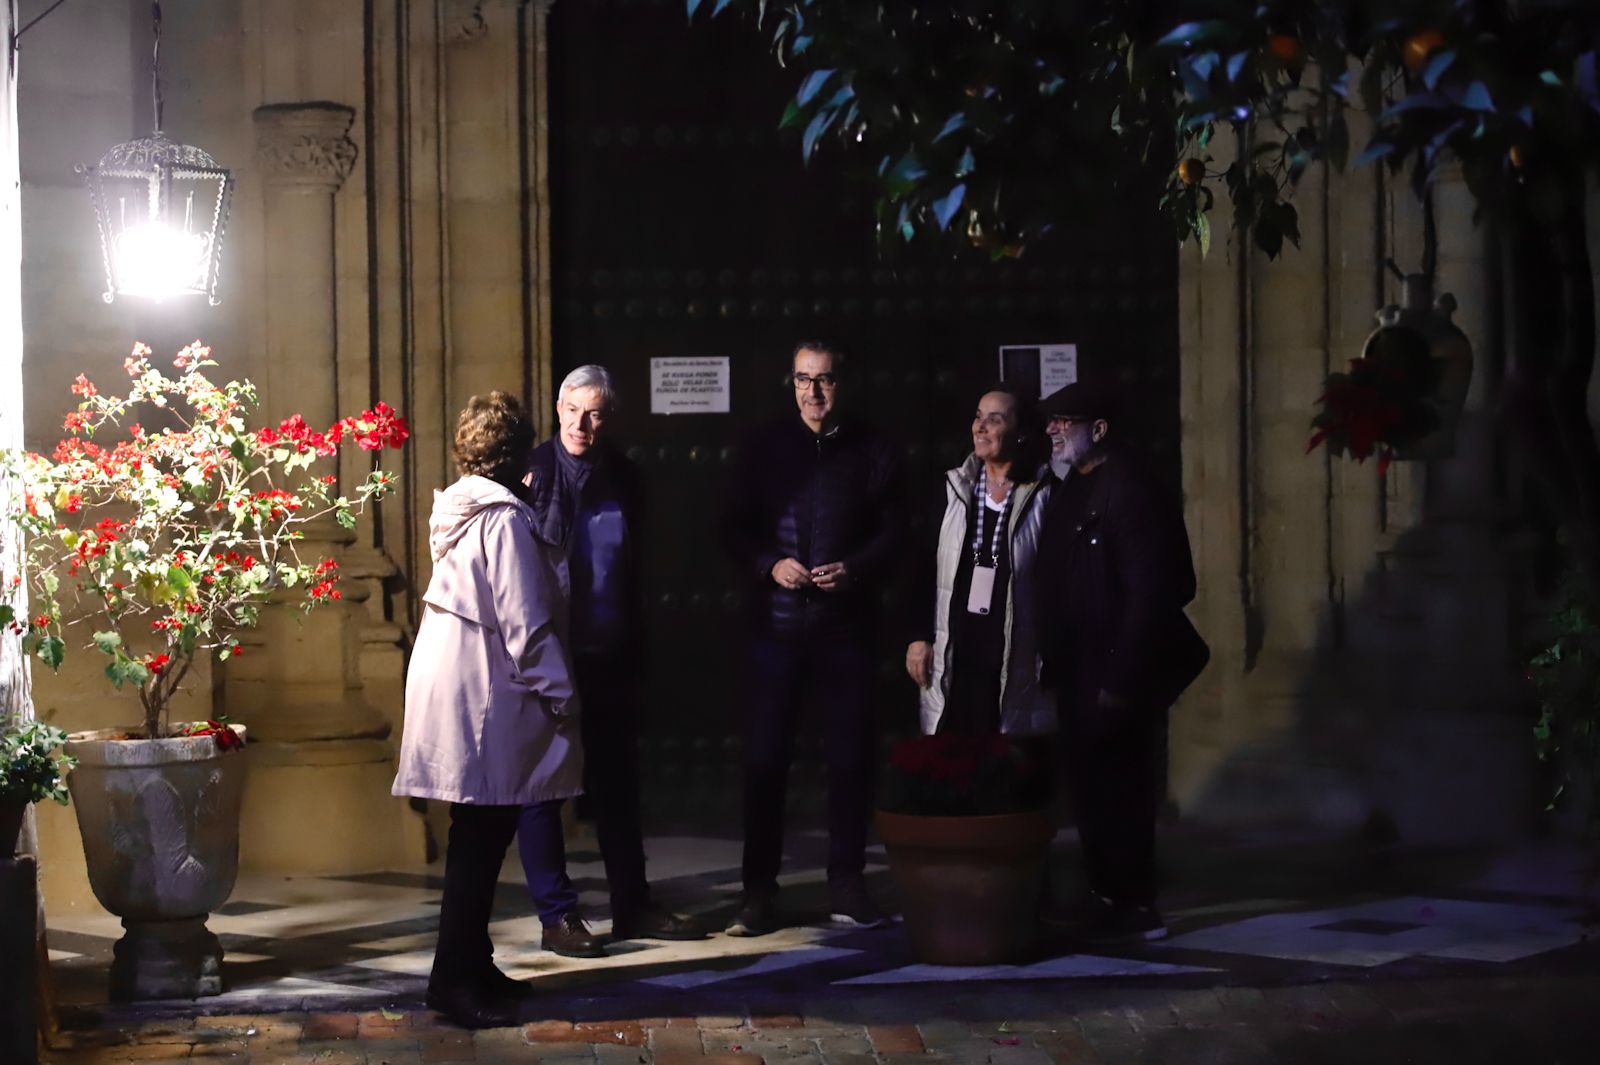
[528,366,706,956]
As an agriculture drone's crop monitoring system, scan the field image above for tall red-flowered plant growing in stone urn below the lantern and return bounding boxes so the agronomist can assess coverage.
[0,341,410,737]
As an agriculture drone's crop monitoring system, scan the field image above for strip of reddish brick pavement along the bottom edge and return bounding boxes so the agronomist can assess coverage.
[45,948,1600,1065]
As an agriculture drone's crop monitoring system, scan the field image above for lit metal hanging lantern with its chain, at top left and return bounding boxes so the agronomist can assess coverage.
[78,3,234,305]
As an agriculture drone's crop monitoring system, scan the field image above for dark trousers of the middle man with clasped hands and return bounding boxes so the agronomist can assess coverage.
[744,636,877,895]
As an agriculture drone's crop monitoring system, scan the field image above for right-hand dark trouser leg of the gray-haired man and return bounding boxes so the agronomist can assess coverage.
[573,652,650,918]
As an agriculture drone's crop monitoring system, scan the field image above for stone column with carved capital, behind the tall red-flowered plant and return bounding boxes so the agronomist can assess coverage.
[222,102,419,872]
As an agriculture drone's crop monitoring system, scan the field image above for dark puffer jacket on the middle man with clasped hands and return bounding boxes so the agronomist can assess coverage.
[723,417,902,640]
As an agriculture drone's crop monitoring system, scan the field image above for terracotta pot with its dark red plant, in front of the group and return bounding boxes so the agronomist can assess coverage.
[877,736,1054,966]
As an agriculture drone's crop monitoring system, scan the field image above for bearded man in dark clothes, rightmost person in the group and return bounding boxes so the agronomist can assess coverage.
[1035,384,1210,942]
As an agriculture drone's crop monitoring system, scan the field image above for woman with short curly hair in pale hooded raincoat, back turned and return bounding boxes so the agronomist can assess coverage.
[394,392,582,1027]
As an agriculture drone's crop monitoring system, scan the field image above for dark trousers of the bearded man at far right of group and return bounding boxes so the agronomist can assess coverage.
[1058,688,1166,907]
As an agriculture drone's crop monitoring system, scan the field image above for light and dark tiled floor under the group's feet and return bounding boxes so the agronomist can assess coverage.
[50,833,1586,1012]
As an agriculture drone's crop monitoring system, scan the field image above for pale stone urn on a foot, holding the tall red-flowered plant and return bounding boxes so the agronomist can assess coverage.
[66,724,245,1001]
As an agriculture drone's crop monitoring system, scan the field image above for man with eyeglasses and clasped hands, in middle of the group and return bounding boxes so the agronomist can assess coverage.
[723,341,901,935]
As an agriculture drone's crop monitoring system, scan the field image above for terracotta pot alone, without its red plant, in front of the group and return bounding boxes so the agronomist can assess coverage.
[877,811,1056,966]
